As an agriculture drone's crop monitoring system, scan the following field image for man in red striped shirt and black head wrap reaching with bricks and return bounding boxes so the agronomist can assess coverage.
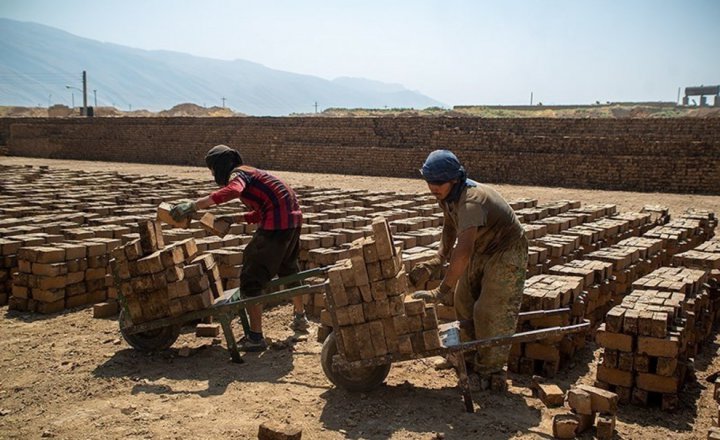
[171,145,309,351]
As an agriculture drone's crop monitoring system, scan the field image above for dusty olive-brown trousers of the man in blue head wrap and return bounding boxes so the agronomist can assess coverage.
[454,237,528,375]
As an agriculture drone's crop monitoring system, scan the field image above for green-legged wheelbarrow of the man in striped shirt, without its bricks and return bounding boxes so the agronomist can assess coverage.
[118,266,332,363]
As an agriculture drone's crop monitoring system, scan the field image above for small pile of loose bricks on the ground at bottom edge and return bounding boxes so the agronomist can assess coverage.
[553,385,618,440]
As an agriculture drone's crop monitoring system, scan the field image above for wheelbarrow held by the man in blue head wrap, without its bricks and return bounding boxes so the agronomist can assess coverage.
[321,308,590,413]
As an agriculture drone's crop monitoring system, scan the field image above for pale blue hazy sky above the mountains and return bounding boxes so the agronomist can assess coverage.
[0,0,720,105]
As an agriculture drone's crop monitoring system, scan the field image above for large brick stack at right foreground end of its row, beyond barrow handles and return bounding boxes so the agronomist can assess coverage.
[596,268,709,409]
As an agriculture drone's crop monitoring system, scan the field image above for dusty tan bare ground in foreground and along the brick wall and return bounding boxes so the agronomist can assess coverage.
[0,157,720,439]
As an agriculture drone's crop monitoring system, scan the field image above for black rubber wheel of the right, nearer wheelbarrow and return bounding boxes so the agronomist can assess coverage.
[320,332,390,392]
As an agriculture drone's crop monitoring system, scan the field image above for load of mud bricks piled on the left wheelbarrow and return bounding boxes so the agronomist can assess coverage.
[112,221,223,324]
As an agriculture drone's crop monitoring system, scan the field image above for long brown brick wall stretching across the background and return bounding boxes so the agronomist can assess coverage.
[0,117,720,194]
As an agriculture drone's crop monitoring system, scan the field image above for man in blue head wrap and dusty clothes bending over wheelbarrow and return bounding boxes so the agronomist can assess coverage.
[409,150,528,389]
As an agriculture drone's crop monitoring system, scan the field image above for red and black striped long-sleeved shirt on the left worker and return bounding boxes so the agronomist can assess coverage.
[210,166,302,230]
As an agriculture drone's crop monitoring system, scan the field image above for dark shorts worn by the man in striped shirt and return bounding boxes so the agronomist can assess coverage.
[240,228,300,297]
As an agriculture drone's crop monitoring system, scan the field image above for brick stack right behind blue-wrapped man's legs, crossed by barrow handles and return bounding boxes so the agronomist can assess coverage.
[508,275,585,377]
